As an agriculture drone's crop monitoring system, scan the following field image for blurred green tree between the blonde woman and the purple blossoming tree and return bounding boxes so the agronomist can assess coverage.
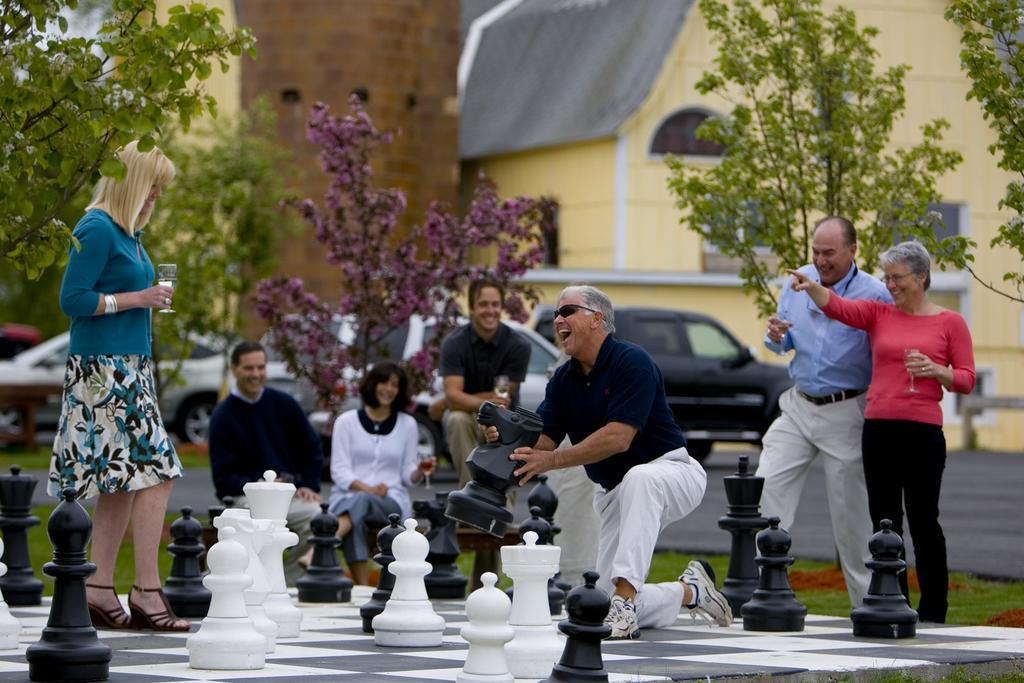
[145,102,300,401]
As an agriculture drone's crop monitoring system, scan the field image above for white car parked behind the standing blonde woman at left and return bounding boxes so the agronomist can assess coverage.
[0,332,296,443]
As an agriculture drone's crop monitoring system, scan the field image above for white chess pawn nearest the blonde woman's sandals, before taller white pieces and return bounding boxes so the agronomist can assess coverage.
[185,526,266,671]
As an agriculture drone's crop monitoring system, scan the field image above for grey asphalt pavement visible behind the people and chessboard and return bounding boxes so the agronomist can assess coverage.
[18,451,1024,580]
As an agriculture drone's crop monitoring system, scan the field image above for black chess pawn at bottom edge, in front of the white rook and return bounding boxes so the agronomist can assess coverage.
[545,571,611,683]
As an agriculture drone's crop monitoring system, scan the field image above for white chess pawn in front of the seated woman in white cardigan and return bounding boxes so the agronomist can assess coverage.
[373,519,444,647]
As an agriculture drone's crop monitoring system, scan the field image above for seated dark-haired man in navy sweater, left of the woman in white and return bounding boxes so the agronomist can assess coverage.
[210,341,324,586]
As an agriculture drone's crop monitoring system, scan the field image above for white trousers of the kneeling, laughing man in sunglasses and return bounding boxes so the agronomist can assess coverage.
[594,449,708,629]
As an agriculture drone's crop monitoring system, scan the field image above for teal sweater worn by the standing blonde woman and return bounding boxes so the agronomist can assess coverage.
[60,209,154,356]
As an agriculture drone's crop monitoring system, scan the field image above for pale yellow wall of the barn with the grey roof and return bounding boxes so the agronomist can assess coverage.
[479,0,1024,451]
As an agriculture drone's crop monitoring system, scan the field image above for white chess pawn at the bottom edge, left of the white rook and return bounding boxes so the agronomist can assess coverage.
[455,571,516,683]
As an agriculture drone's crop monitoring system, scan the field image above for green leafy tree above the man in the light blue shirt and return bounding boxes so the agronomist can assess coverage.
[668,0,969,314]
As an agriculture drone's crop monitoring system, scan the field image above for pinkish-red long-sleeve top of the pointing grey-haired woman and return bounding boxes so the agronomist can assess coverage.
[822,294,975,425]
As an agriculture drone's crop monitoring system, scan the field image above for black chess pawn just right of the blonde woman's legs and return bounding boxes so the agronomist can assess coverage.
[164,507,213,618]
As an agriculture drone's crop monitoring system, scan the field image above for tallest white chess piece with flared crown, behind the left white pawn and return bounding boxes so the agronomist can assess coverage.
[243,470,302,638]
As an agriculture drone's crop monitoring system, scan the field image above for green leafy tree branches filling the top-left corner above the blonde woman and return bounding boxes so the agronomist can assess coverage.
[0,0,253,278]
